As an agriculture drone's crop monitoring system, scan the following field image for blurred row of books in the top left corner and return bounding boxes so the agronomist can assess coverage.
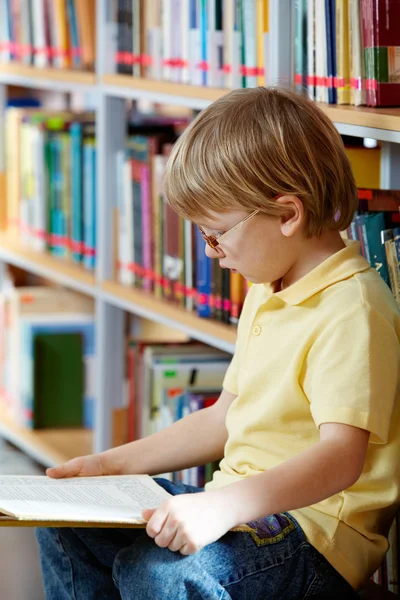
[0,0,96,70]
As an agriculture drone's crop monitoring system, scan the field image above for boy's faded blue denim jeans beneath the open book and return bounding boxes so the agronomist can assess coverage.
[36,479,357,600]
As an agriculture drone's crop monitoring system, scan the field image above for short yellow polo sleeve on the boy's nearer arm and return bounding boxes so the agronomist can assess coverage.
[303,305,400,444]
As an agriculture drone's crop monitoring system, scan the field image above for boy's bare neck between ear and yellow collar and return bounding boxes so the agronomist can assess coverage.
[273,231,346,292]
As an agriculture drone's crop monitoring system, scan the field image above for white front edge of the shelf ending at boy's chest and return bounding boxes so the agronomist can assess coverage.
[99,289,235,354]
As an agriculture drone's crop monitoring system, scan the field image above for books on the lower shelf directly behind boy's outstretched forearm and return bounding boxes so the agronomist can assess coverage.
[126,326,231,486]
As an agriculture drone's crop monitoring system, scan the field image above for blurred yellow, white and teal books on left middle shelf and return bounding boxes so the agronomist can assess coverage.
[5,108,97,270]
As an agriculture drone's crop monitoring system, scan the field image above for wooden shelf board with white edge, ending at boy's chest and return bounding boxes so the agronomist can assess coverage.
[101,281,236,353]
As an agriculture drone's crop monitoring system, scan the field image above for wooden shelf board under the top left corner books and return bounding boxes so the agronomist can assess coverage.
[0,63,96,92]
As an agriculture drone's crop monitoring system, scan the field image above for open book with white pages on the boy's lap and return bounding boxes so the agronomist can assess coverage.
[0,475,171,527]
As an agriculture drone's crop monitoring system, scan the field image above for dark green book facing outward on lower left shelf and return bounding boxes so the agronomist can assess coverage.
[33,333,85,429]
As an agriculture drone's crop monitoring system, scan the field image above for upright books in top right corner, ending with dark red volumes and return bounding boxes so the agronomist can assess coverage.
[294,0,400,106]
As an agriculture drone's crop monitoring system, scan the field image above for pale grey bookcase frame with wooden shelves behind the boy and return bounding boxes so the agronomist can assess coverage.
[0,0,400,464]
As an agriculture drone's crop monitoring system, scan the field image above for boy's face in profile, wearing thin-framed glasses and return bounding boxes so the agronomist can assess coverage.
[198,199,302,283]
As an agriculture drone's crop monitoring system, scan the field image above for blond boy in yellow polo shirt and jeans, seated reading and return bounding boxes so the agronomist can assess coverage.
[37,88,400,600]
